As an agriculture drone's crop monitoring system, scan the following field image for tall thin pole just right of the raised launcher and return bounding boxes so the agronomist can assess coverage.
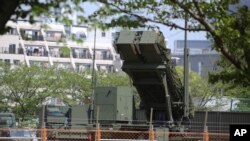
[184,0,189,117]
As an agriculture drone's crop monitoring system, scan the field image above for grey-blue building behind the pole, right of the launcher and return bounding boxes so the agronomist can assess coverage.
[172,40,220,77]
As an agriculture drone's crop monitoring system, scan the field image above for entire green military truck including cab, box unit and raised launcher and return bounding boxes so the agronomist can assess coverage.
[40,31,191,139]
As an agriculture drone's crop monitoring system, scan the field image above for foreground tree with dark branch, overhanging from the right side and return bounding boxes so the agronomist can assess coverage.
[83,0,250,85]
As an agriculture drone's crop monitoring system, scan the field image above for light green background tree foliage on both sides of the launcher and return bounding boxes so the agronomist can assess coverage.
[0,64,229,119]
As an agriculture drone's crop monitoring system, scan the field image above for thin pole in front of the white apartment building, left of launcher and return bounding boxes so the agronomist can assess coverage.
[90,27,96,123]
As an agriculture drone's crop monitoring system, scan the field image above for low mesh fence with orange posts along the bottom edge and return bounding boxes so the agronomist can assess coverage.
[0,128,229,141]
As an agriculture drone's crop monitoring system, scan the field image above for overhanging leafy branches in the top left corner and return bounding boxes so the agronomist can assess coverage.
[0,0,85,34]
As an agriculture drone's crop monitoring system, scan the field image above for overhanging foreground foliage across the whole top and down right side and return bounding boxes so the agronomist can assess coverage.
[0,0,250,96]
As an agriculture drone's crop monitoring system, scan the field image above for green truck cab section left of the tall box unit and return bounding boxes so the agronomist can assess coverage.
[37,105,93,141]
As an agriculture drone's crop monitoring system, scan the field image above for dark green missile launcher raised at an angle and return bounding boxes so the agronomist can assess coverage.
[114,31,193,125]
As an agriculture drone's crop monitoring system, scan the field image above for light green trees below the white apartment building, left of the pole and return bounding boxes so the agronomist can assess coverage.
[0,64,90,120]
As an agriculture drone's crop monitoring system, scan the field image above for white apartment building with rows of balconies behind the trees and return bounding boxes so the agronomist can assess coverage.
[0,21,121,72]
